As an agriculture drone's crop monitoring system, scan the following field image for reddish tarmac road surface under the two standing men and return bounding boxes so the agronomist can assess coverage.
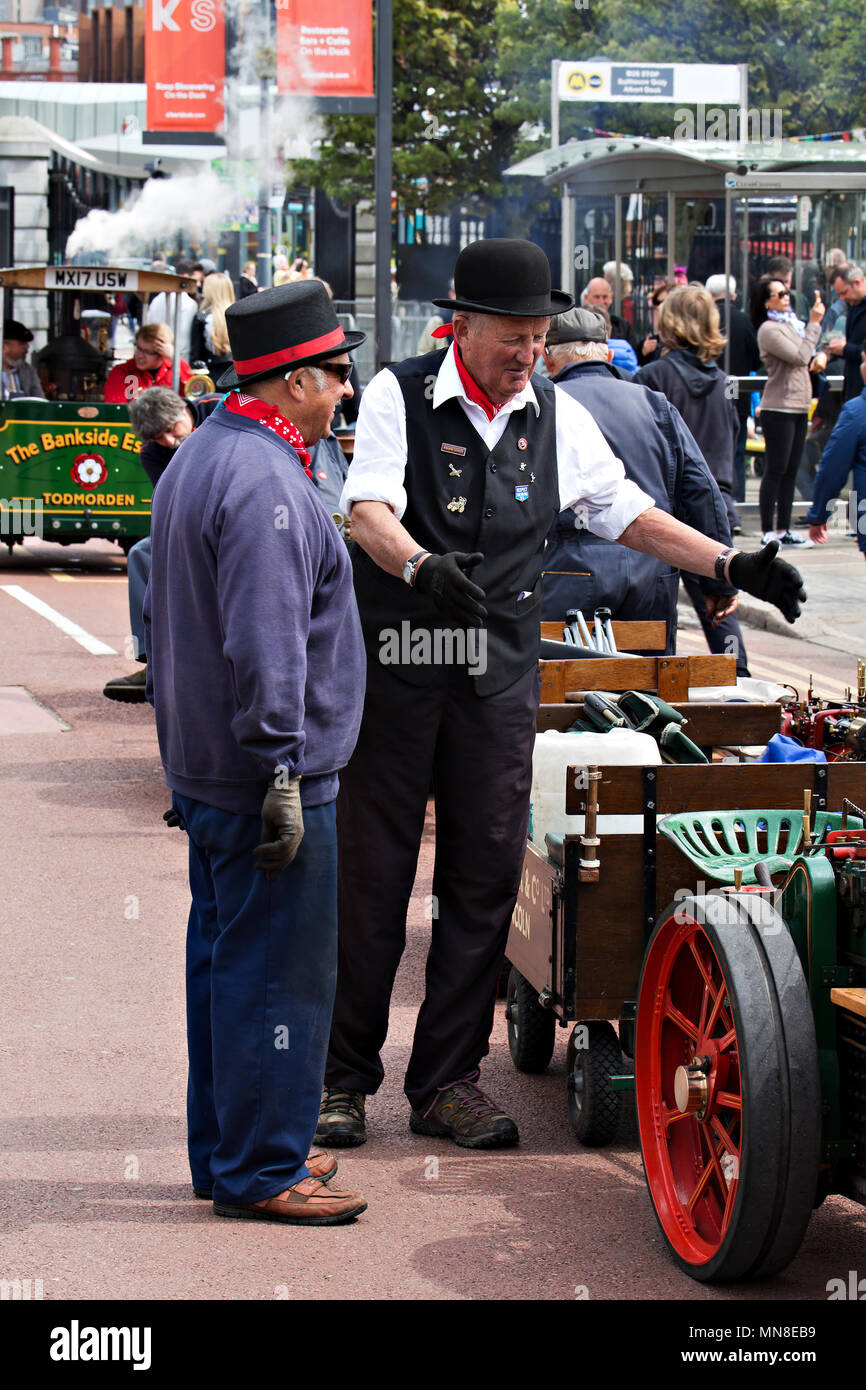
[0,538,866,1304]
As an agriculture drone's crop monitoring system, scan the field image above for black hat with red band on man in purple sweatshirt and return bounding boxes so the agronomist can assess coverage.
[217,279,367,391]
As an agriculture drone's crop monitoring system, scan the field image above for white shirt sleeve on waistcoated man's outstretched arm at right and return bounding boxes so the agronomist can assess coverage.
[555,386,655,541]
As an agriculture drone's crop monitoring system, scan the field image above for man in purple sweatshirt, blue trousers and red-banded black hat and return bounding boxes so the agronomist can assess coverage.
[145,281,366,1225]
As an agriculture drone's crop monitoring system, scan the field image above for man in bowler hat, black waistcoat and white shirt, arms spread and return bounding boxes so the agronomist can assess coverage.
[318,239,805,1148]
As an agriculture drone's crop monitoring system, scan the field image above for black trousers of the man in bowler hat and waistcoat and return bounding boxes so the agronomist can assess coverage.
[325,660,539,1111]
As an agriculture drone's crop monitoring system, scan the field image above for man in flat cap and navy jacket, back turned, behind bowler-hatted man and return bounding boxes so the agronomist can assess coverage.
[541,309,746,674]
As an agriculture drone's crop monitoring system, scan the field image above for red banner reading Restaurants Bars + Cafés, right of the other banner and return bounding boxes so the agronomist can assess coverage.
[277,0,373,96]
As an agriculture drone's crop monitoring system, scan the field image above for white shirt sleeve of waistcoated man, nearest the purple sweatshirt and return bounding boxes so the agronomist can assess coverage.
[339,370,407,521]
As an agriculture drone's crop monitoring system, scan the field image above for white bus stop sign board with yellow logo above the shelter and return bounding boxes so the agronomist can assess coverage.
[557,63,741,106]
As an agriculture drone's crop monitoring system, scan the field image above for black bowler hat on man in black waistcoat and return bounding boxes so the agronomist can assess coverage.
[434,236,574,318]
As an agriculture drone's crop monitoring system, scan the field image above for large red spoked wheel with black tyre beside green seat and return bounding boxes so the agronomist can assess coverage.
[635,894,820,1282]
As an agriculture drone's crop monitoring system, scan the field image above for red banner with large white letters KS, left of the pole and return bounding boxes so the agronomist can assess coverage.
[145,0,225,133]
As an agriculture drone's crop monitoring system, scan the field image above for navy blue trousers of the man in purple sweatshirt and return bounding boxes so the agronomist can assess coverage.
[174,792,336,1204]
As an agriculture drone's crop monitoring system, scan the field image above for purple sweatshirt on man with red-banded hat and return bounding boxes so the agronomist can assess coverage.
[145,406,366,815]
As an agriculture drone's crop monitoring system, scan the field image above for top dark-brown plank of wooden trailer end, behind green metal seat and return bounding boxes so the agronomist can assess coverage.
[566,763,866,816]
